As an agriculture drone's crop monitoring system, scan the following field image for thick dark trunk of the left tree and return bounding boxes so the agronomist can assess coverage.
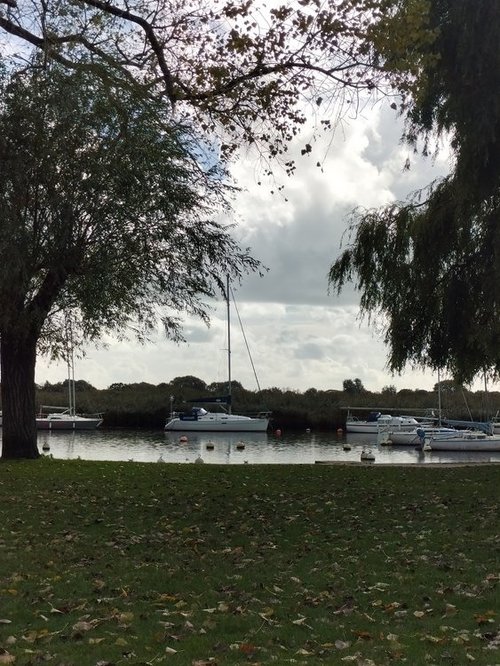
[0,331,40,459]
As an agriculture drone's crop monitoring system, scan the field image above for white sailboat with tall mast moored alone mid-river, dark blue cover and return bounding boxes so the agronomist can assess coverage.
[165,278,269,432]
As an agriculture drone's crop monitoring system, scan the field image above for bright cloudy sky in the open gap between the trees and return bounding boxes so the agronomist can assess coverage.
[36,101,460,392]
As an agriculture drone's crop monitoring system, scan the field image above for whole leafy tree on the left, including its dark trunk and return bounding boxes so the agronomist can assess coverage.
[0,66,257,458]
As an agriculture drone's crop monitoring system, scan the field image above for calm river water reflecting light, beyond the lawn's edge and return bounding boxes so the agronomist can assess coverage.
[16,429,500,465]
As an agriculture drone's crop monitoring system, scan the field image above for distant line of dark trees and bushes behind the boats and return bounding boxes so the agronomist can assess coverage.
[30,375,500,431]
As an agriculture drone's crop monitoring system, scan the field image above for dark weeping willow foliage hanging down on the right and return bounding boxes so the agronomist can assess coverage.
[329,0,500,381]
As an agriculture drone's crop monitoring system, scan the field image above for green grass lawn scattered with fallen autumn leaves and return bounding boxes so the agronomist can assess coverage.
[0,458,500,666]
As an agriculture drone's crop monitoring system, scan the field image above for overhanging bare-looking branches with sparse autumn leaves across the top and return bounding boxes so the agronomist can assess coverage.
[0,0,429,170]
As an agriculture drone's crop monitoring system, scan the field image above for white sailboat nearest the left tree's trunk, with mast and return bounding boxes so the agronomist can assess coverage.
[36,323,103,430]
